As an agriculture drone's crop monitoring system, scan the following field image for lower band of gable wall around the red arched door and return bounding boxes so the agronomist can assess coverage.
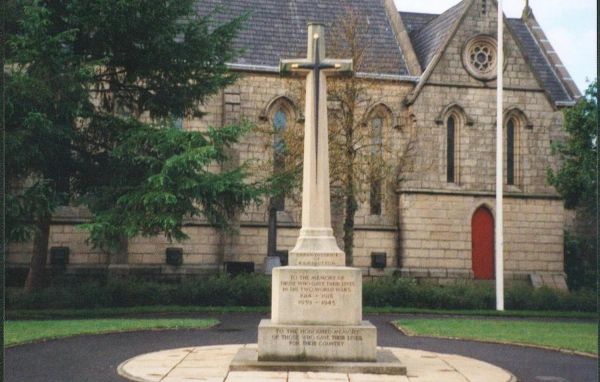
[400,192,564,283]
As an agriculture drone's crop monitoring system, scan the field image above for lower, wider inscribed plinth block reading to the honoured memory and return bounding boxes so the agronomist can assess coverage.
[258,319,377,362]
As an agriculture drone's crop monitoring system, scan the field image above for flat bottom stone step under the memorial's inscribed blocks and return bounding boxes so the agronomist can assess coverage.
[229,348,406,375]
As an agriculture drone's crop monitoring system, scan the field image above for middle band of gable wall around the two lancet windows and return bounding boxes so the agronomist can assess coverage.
[402,86,564,195]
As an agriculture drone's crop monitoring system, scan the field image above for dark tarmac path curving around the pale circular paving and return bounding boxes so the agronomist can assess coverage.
[4,315,598,382]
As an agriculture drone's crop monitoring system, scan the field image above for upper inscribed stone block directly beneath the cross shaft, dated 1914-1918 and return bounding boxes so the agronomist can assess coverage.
[271,266,362,325]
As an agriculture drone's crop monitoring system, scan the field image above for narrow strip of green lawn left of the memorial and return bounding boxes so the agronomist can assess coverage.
[4,318,219,346]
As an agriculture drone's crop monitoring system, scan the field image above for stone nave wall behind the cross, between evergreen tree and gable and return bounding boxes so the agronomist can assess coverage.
[196,73,412,275]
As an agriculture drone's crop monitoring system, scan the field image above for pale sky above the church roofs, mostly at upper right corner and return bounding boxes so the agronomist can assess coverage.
[394,0,598,93]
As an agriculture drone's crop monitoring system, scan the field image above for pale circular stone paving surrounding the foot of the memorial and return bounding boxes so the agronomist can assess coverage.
[118,344,517,382]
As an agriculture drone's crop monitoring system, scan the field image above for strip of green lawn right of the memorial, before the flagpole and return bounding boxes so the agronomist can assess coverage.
[395,319,598,354]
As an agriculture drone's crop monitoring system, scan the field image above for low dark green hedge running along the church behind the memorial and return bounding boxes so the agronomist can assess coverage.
[6,276,596,312]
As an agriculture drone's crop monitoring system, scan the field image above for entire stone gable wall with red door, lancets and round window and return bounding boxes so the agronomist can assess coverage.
[392,2,565,283]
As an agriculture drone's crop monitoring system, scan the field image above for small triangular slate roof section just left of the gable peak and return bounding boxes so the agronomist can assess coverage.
[400,0,468,71]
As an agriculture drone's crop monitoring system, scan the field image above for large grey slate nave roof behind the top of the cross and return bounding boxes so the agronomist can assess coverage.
[196,0,409,75]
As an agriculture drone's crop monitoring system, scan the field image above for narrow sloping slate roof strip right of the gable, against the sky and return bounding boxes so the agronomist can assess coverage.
[508,19,571,102]
